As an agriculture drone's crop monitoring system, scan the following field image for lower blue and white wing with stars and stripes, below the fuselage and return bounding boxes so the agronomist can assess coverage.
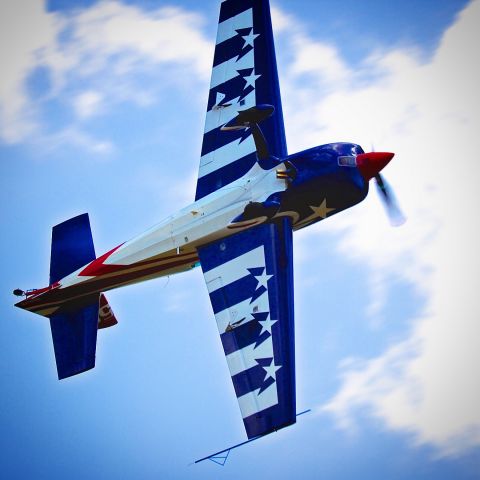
[199,219,296,438]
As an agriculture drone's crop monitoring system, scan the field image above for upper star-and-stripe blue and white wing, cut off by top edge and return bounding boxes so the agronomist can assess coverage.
[195,0,287,200]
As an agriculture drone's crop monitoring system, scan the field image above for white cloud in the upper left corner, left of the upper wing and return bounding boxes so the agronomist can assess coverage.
[0,0,212,150]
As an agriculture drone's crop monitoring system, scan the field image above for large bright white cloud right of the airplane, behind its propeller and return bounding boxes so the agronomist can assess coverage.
[282,1,480,454]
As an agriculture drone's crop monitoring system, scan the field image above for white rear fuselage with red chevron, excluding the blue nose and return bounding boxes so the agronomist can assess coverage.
[18,164,287,316]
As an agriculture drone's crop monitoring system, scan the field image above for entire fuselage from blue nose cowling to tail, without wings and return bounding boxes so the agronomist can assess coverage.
[17,143,368,316]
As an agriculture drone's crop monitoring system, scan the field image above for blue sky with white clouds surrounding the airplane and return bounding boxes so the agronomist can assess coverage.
[0,0,480,480]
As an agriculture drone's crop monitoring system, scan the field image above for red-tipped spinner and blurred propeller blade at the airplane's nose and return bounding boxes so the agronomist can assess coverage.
[356,152,406,227]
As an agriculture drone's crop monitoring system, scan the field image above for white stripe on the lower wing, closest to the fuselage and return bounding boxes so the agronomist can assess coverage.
[203,245,265,286]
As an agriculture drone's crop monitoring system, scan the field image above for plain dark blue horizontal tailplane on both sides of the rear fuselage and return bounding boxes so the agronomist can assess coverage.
[50,213,99,380]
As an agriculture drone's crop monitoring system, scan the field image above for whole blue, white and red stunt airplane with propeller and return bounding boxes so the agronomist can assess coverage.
[14,0,404,464]
